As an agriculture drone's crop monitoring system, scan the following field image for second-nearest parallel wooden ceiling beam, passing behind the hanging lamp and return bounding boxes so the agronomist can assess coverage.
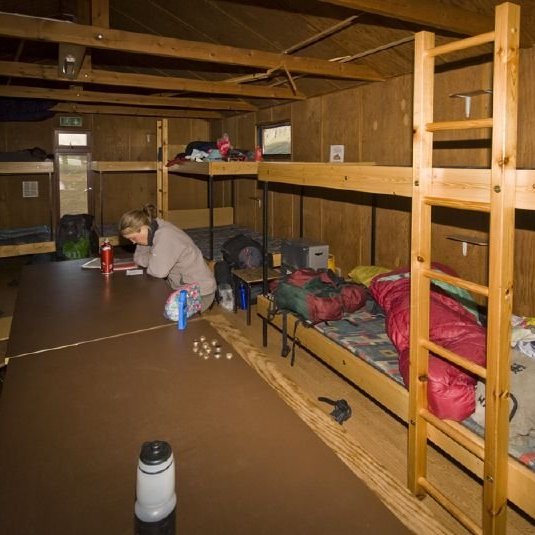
[0,61,305,100]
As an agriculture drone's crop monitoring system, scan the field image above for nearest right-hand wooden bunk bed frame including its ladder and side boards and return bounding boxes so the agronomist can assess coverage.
[257,3,535,533]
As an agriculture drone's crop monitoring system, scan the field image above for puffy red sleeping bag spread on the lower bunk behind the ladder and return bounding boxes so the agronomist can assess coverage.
[370,266,486,421]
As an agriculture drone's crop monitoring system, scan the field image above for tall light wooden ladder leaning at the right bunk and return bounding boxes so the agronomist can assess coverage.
[408,3,520,533]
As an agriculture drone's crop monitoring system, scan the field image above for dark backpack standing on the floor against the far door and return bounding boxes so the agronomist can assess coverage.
[56,214,98,260]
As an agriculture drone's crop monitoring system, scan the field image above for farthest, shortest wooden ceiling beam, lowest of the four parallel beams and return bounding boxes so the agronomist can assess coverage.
[50,102,224,119]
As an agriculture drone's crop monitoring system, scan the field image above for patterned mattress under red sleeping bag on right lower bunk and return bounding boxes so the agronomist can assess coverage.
[314,299,535,471]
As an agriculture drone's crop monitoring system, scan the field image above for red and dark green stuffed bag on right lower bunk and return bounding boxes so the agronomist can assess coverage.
[273,268,367,323]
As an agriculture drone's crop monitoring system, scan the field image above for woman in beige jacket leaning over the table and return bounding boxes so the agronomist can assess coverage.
[119,205,216,312]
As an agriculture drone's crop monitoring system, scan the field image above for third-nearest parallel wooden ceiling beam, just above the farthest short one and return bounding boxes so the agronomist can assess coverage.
[0,85,257,111]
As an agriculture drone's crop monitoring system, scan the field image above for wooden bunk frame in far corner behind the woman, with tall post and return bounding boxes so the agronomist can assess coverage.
[157,119,258,260]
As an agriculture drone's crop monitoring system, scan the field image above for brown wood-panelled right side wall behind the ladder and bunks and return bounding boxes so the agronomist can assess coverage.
[214,49,535,315]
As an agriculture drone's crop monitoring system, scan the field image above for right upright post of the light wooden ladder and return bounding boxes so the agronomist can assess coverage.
[483,4,520,533]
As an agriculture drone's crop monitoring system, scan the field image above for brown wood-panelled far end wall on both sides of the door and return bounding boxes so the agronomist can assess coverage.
[0,115,218,233]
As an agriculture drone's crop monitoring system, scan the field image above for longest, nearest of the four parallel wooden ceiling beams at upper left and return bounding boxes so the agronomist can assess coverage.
[0,12,384,81]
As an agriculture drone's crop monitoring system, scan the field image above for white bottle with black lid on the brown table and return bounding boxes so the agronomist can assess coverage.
[135,440,176,522]
